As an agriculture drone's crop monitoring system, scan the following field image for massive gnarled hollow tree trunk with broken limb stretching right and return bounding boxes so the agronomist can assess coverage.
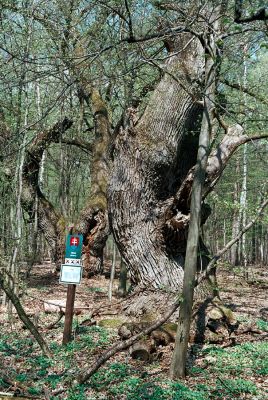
[108,29,267,304]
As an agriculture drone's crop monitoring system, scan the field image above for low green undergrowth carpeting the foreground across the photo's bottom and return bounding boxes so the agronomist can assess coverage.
[0,320,268,400]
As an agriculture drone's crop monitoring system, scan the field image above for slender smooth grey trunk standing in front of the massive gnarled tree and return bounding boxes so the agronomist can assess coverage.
[170,3,220,379]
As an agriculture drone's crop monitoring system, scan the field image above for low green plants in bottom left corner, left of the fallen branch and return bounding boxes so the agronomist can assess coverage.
[0,326,112,399]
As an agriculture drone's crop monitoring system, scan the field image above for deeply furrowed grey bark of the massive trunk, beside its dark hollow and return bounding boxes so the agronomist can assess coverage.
[108,34,203,290]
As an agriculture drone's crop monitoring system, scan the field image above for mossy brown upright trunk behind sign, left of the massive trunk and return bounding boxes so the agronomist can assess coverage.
[65,34,111,273]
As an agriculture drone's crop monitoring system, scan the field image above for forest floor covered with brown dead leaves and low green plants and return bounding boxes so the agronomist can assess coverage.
[0,264,268,400]
